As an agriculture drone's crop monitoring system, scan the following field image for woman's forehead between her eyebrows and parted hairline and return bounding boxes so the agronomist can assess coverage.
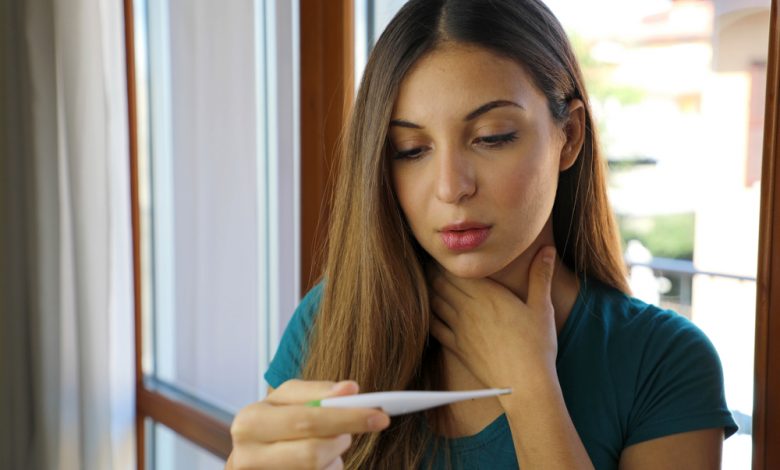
[393,43,545,118]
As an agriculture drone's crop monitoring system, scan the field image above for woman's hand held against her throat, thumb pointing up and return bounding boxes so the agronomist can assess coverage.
[428,246,558,392]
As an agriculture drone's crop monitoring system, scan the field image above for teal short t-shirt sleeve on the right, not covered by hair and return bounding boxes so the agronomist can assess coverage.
[625,310,737,446]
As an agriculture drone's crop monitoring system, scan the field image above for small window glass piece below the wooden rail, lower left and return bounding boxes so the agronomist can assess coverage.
[146,419,225,470]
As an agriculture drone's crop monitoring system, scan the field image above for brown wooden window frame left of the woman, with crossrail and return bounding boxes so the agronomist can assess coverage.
[123,0,354,469]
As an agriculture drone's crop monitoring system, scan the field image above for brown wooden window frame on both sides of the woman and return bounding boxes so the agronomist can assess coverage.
[123,0,780,470]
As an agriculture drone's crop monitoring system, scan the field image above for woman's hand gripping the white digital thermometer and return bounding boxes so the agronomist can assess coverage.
[226,380,390,470]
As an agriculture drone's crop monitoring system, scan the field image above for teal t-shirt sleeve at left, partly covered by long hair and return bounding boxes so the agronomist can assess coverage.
[263,283,323,388]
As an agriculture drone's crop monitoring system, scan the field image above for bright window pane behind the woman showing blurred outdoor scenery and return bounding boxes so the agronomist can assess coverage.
[356,0,770,469]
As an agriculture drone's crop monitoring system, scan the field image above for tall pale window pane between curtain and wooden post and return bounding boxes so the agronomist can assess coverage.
[134,0,299,412]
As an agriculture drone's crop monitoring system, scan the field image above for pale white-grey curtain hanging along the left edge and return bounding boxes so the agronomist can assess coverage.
[0,0,135,470]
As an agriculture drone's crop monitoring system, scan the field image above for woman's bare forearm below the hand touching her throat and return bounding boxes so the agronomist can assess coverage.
[501,375,593,470]
